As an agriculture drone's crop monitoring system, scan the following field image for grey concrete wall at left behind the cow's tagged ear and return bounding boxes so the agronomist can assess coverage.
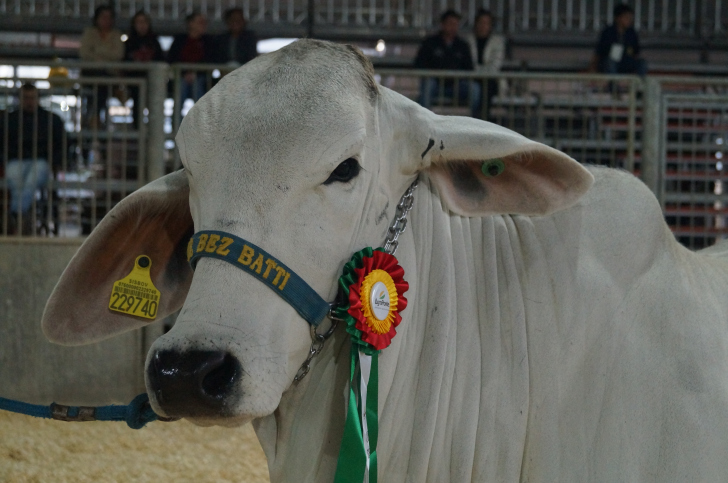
[0,238,162,405]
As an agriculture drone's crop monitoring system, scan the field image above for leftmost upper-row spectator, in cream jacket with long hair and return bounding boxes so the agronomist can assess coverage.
[79,5,124,124]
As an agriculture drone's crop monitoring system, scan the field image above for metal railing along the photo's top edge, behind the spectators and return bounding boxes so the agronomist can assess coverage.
[0,0,728,37]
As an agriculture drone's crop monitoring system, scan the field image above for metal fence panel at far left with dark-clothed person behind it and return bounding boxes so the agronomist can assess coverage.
[0,65,148,236]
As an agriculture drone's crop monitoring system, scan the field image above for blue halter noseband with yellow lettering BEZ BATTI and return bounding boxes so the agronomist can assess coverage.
[187,230,331,327]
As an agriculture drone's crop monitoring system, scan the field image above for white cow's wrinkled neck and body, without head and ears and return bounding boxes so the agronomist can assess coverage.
[254,164,728,483]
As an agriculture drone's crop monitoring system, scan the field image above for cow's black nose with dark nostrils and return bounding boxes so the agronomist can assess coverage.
[147,350,242,418]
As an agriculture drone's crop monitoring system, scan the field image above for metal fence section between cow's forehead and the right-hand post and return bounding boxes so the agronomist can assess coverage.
[377,69,641,174]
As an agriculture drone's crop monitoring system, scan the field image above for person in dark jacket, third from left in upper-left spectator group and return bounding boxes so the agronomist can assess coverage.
[167,12,215,102]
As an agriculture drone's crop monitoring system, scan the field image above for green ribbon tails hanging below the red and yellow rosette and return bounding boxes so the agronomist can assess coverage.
[334,344,379,483]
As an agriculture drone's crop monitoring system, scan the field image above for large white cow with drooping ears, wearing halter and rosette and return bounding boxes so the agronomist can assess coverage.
[43,40,728,483]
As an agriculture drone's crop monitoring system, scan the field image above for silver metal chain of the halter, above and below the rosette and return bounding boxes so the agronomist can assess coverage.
[293,180,417,383]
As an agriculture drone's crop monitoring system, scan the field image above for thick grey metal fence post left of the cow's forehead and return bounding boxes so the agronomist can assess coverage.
[145,62,169,182]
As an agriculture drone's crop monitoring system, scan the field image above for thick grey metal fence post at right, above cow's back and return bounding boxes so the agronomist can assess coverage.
[642,77,664,203]
